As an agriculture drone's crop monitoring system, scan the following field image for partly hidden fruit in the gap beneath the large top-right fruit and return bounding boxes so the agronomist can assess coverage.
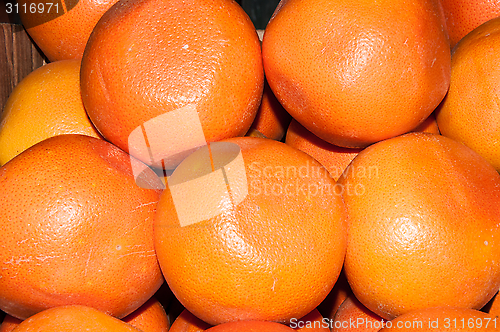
[285,120,363,181]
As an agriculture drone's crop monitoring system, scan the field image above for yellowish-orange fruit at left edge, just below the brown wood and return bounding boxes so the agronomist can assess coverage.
[0,60,100,165]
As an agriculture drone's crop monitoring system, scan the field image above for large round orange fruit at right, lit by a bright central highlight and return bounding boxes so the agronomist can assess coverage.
[339,133,500,319]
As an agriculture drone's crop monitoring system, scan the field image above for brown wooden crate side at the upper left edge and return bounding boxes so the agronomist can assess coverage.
[0,23,46,116]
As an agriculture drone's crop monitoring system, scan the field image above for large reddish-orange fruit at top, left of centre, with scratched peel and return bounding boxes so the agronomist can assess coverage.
[81,0,264,169]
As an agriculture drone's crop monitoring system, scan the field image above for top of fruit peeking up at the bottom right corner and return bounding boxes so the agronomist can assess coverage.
[380,307,499,332]
